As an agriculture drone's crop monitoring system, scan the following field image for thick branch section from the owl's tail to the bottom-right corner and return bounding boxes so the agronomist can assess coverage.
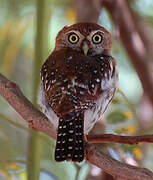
[86,144,153,180]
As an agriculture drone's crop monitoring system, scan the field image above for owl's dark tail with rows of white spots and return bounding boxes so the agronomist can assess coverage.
[55,112,84,162]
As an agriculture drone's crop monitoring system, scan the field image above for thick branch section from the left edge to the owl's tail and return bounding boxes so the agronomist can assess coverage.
[0,74,56,138]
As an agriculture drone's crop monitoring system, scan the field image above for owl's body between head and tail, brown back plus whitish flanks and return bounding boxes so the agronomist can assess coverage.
[39,49,117,133]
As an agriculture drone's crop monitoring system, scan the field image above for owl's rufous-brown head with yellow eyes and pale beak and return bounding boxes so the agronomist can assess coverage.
[55,23,112,55]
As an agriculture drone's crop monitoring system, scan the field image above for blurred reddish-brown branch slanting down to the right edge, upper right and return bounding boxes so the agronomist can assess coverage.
[102,0,153,105]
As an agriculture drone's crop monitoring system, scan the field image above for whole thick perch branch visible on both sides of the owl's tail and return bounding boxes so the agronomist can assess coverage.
[0,74,153,180]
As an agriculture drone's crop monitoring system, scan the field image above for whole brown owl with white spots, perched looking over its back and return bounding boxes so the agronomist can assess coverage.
[38,23,118,162]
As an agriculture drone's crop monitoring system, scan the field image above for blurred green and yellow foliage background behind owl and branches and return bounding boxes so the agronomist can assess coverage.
[0,0,153,180]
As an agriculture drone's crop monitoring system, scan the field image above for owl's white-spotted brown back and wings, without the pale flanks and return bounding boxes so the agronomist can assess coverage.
[41,50,116,114]
